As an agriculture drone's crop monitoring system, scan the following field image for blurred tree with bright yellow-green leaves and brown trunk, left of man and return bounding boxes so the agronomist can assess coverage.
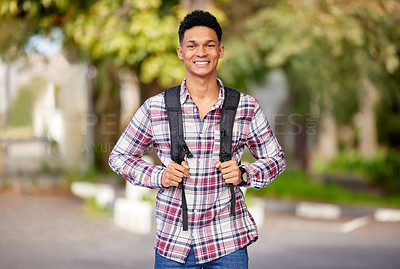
[64,0,184,167]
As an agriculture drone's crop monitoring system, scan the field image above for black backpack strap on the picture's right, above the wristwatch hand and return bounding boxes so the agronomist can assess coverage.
[219,87,240,215]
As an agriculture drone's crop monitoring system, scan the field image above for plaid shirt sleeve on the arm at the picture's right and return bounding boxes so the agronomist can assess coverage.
[243,99,286,189]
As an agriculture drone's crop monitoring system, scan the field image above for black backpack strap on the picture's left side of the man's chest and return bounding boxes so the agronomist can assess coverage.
[164,86,193,231]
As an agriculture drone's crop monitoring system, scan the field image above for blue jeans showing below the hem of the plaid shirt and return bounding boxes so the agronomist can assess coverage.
[154,247,249,269]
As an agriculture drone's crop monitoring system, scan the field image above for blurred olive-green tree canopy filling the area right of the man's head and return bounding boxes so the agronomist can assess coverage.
[221,0,400,165]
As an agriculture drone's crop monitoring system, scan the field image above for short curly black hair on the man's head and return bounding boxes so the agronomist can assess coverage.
[178,9,222,43]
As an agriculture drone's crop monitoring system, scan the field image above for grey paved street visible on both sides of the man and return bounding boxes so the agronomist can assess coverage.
[0,193,400,269]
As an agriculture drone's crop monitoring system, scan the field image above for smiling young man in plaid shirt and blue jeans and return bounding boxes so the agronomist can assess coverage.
[109,10,285,268]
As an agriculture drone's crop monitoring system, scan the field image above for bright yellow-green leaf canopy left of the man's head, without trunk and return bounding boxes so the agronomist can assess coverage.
[65,0,183,86]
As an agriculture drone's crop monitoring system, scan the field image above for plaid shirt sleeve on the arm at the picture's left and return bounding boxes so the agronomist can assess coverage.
[108,99,165,189]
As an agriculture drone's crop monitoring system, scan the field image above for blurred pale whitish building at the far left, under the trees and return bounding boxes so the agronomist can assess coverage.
[0,52,92,172]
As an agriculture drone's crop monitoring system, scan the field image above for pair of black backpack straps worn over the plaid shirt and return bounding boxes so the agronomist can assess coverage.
[164,86,240,231]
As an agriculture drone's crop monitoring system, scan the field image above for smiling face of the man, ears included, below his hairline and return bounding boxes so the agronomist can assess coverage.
[177,26,224,77]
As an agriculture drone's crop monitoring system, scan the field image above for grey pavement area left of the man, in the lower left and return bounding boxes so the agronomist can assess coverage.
[0,193,154,269]
